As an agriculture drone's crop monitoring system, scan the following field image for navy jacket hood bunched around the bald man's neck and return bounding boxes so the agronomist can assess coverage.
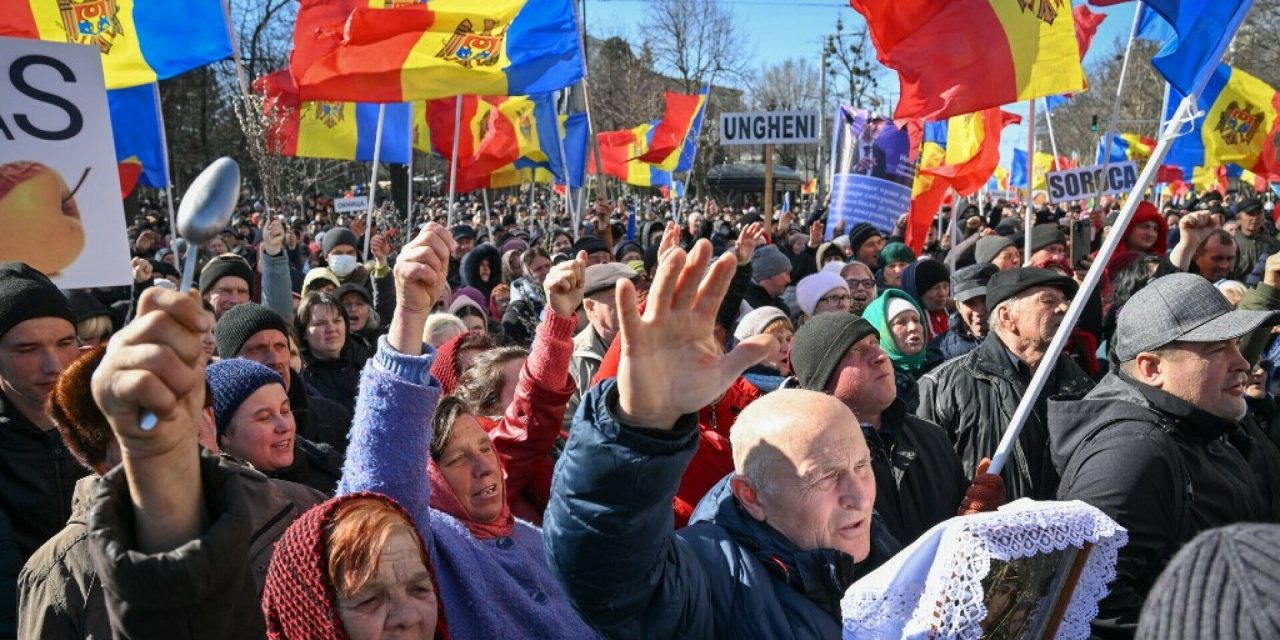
[689,475,900,620]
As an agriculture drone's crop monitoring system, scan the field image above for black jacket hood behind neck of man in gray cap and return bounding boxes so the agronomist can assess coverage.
[1048,371,1238,471]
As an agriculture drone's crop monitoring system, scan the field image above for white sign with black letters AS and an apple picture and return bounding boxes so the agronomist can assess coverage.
[0,37,133,289]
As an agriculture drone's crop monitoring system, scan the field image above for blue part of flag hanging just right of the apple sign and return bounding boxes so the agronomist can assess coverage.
[106,83,169,189]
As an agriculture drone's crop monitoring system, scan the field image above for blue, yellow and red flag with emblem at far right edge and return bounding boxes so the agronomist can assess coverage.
[1165,64,1280,178]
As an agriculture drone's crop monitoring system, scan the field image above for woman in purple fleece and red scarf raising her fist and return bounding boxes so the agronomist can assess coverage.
[339,223,595,637]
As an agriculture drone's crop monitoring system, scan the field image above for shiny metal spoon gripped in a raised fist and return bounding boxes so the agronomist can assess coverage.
[138,157,241,431]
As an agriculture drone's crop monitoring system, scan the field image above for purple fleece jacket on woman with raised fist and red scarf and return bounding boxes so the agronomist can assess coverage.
[338,337,599,639]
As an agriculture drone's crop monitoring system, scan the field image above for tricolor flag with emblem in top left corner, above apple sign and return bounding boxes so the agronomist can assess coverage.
[0,0,232,88]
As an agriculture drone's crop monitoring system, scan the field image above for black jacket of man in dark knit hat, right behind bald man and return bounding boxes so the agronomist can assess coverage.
[863,399,969,544]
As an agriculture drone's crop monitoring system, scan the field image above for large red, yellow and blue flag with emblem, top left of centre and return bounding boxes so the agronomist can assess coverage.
[289,0,584,102]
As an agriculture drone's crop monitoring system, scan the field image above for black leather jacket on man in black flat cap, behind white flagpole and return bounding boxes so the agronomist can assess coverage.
[915,333,1093,500]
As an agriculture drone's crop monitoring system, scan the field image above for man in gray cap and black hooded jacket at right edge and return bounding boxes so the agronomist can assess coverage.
[1050,274,1276,637]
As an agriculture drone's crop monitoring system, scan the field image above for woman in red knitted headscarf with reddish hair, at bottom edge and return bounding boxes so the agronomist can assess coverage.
[262,493,448,640]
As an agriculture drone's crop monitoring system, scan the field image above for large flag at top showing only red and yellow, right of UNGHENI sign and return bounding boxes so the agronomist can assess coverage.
[850,0,1084,120]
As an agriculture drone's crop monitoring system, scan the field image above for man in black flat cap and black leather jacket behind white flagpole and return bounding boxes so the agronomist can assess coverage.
[916,268,1093,500]
